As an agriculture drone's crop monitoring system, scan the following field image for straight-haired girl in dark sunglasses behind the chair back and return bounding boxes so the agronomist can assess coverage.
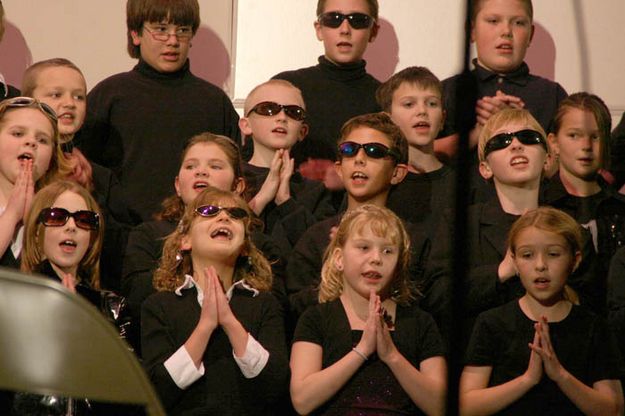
[13,181,130,415]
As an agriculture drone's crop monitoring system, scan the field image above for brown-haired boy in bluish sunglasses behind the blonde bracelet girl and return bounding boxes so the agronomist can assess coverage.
[286,113,429,319]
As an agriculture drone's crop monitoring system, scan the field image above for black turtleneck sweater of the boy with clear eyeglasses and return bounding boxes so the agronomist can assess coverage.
[75,61,239,221]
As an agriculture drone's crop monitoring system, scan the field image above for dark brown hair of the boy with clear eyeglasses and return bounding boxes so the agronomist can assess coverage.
[126,0,200,58]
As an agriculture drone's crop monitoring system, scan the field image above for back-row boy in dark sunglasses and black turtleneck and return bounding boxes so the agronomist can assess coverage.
[274,0,380,172]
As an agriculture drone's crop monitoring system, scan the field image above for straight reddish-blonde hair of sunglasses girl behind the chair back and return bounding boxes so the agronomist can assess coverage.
[21,180,104,289]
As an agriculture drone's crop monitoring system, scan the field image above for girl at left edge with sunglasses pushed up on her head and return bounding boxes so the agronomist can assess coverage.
[0,97,71,268]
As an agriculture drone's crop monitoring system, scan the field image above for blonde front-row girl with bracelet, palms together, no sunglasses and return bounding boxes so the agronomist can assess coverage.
[291,205,446,415]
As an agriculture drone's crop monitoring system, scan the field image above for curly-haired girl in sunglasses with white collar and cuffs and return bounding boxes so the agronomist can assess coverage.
[141,188,288,415]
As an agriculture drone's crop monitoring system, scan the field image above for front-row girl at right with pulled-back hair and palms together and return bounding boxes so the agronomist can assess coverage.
[460,207,625,415]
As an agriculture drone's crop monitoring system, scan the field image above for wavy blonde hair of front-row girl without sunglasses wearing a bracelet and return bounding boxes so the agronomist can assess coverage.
[319,205,416,304]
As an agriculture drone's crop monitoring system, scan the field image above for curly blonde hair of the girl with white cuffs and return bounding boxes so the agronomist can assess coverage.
[154,187,272,291]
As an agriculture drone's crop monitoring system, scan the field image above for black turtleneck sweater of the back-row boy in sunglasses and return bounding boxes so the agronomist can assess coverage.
[274,56,381,165]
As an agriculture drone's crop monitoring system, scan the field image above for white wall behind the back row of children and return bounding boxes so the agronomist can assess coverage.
[0,0,625,123]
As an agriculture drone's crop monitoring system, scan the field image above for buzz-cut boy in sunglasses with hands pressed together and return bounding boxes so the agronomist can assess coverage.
[239,79,335,255]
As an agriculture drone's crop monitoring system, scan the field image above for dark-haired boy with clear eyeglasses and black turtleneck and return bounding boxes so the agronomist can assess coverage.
[75,0,239,221]
